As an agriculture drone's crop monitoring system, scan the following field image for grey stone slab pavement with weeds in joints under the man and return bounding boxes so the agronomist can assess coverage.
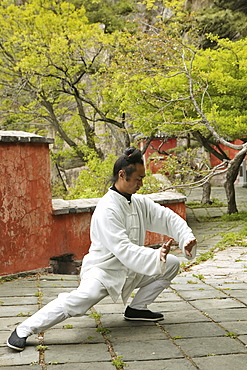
[0,188,247,370]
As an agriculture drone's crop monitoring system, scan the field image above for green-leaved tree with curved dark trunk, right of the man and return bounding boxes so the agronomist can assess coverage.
[100,13,247,213]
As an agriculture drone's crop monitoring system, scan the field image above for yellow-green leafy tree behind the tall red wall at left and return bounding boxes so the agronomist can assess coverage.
[0,0,129,163]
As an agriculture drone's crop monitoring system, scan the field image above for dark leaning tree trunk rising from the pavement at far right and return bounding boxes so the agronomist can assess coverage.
[224,150,246,215]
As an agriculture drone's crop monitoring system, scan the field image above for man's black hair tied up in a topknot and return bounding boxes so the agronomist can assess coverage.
[110,146,144,183]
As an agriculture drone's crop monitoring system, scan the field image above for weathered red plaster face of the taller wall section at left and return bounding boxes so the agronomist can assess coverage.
[0,143,52,274]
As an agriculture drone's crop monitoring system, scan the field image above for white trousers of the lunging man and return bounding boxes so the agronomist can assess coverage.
[16,254,179,337]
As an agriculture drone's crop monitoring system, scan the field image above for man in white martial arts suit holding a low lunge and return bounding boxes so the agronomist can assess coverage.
[7,148,196,351]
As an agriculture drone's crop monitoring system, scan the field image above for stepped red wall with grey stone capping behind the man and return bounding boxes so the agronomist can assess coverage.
[0,131,186,276]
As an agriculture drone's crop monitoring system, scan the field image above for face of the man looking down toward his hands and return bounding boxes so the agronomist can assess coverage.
[115,163,145,194]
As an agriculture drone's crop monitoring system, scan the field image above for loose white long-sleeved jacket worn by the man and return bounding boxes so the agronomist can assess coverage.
[81,189,196,303]
